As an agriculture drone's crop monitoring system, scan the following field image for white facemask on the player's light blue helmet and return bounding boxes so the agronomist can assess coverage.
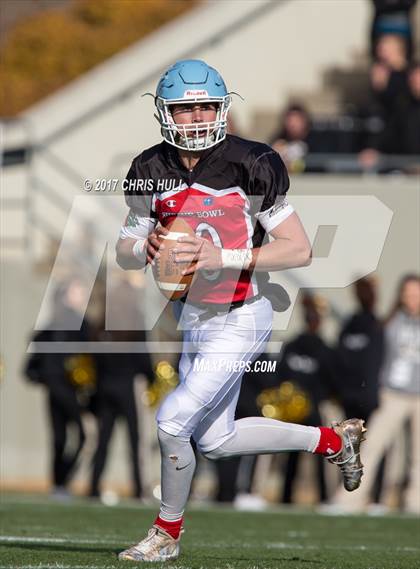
[155,95,231,152]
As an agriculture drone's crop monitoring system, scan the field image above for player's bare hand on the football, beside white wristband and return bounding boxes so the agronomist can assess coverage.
[173,232,222,275]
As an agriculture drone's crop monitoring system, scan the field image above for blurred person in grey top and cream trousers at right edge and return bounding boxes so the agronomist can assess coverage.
[335,275,420,514]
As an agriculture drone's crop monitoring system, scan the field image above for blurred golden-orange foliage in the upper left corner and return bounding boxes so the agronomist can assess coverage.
[0,0,197,117]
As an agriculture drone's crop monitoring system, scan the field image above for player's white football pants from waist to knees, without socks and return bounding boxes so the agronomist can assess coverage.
[157,298,273,453]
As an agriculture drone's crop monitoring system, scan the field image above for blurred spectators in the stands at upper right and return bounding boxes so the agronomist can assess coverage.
[269,0,420,174]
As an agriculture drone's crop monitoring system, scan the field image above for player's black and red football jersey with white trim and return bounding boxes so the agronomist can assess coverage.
[123,135,293,303]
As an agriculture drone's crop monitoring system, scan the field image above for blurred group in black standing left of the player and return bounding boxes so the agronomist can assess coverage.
[25,275,154,498]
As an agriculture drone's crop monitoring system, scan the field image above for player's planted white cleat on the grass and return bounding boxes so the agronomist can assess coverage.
[118,526,180,561]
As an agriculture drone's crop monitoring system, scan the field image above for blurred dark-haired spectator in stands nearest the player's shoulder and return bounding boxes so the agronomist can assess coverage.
[270,103,313,173]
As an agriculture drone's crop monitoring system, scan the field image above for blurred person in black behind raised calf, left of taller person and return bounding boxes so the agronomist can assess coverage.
[277,294,335,503]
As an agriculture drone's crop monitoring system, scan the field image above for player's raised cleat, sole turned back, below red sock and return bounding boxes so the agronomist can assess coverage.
[328,419,367,492]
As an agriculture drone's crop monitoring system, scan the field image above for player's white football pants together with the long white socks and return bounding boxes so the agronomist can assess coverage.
[157,298,320,521]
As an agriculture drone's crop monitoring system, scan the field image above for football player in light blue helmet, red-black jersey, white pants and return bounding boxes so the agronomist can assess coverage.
[117,60,365,561]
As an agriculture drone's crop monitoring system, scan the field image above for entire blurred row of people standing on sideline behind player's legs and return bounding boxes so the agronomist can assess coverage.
[25,274,420,512]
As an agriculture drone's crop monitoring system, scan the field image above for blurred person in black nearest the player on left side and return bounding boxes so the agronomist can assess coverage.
[89,275,153,498]
